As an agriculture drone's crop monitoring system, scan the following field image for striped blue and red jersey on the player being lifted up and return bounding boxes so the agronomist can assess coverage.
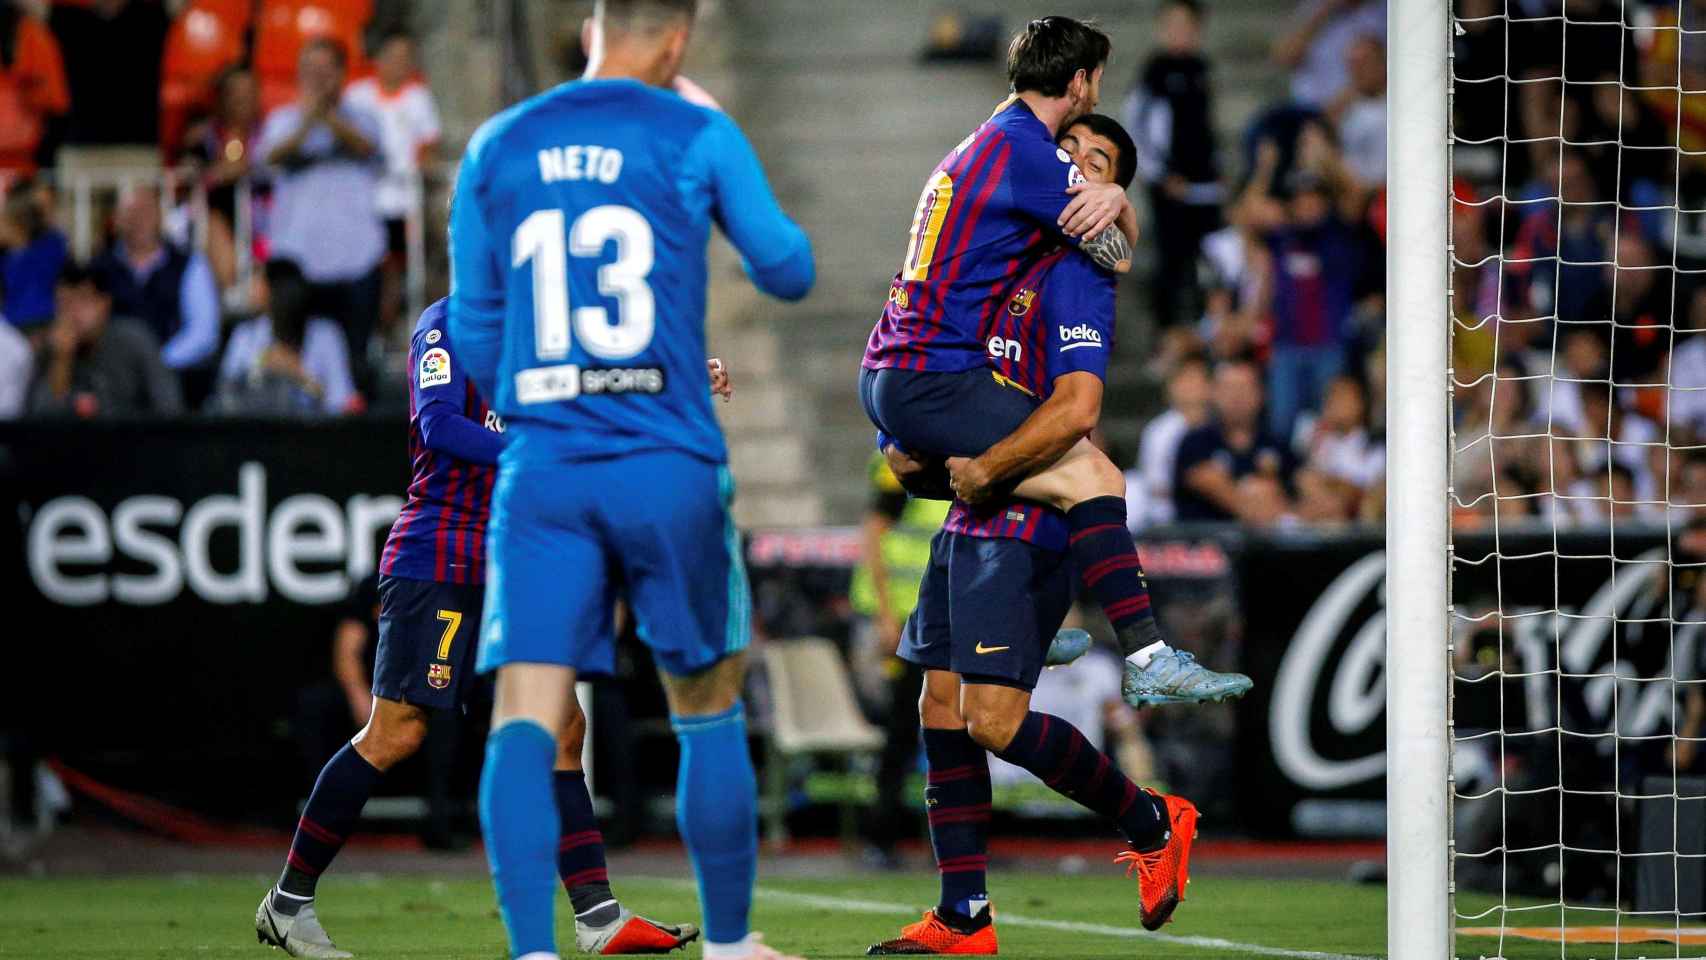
[863,97,1083,372]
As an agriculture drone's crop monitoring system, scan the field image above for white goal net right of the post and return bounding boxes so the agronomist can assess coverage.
[1446,0,1706,957]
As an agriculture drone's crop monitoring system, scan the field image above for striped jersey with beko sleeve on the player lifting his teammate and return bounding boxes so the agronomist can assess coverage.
[942,249,1114,551]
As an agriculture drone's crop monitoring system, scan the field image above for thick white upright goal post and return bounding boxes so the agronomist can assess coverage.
[1385,0,1452,960]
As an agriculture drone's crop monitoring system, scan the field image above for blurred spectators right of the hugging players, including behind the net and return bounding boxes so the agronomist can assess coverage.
[1126,0,1706,530]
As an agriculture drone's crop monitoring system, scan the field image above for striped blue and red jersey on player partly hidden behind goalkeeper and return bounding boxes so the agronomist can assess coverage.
[379,300,503,583]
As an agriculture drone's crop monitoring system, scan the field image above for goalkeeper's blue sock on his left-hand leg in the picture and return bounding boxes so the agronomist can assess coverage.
[479,720,558,957]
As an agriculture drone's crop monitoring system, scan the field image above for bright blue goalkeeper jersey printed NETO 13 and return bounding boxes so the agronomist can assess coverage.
[450,80,815,464]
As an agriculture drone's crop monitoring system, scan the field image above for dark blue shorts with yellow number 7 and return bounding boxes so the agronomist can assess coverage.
[374,576,486,709]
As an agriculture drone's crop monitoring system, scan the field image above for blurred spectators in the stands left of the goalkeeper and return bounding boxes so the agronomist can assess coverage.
[0,0,438,418]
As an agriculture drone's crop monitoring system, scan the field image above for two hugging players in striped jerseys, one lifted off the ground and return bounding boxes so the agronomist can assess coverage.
[860,17,1250,955]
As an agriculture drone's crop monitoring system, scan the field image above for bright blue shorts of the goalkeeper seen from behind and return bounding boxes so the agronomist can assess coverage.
[478,450,752,677]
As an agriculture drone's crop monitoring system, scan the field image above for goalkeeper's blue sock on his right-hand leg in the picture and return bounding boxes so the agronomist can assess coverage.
[670,703,757,957]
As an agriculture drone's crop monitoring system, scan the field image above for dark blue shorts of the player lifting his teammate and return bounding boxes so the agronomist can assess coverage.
[899,530,1075,691]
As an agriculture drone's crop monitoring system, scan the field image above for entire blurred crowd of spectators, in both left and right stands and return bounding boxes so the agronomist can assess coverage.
[0,0,1706,530]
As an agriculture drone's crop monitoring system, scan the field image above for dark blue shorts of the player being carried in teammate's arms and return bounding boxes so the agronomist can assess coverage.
[858,367,1041,457]
